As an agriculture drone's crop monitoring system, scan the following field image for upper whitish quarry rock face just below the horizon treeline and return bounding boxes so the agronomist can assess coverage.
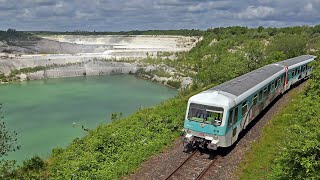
[0,35,199,74]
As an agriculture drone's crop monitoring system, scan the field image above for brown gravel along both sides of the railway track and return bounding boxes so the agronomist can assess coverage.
[123,82,306,180]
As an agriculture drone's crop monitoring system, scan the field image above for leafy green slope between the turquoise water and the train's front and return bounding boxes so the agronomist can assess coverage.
[50,97,187,179]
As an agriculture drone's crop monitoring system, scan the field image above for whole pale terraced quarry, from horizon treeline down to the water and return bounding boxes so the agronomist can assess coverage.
[0,35,201,87]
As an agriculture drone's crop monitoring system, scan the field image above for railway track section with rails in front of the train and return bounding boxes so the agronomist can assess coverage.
[166,150,218,180]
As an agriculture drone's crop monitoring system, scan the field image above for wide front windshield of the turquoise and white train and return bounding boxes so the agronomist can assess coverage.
[188,104,223,126]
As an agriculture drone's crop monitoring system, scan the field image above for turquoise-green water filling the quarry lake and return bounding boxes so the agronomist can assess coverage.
[0,75,177,162]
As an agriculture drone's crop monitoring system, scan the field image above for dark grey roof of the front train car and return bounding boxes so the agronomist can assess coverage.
[207,64,283,96]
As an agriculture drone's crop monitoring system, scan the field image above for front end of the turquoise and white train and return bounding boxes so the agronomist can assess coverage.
[183,103,229,150]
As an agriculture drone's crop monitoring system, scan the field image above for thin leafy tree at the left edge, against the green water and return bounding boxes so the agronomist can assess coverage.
[0,104,20,158]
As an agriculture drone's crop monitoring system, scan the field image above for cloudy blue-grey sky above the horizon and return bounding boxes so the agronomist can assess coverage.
[0,0,320,31]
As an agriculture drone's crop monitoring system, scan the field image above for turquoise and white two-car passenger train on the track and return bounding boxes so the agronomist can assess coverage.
[182,55,317,150]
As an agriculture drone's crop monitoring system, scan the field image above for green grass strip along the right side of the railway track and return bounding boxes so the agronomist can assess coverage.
[236,84,302,179]
